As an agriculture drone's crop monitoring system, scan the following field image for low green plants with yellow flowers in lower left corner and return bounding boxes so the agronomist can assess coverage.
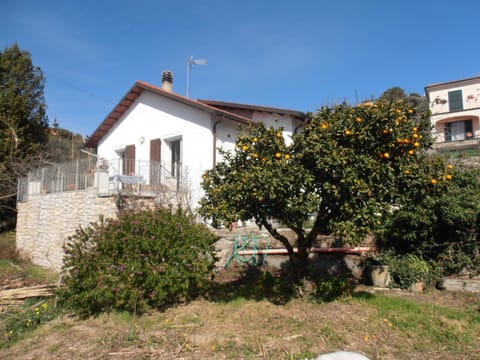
[0,299,60,348]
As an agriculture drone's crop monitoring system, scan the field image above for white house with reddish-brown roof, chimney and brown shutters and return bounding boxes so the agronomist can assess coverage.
[86,71,305,208]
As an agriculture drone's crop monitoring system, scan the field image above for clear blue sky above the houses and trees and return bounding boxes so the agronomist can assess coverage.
[0,0,480,135]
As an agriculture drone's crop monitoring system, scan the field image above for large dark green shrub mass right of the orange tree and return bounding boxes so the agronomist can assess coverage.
[378,165,480,275]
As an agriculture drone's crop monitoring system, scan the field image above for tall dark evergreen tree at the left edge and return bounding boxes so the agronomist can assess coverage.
[0,44,48,231]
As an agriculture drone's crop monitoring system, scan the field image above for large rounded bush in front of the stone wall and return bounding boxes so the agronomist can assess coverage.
[58,209,215,315]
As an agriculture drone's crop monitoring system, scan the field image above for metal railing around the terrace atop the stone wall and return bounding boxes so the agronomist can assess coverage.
[17,159,186,202]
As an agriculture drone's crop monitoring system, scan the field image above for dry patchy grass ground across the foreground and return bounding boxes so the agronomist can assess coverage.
[0,292,480,360]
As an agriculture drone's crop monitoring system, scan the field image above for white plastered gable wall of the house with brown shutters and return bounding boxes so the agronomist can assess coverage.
[98,91,213,207]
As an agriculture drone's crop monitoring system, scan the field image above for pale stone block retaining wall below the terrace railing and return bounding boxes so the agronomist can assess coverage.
[16,188,117,271]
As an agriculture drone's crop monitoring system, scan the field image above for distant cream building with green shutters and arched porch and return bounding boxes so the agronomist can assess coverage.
[425,77,480,151]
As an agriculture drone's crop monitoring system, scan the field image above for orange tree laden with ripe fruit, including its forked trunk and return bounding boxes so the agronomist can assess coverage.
[199,102,451,279]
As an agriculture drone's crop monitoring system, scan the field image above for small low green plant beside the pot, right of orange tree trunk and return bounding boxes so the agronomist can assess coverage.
[384,254,440,289]
